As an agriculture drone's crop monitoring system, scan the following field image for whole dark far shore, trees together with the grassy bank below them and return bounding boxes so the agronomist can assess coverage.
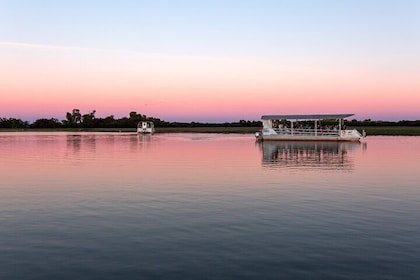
[0,109,420,135]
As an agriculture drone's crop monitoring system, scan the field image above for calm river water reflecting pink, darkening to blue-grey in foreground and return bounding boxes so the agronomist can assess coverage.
[0,133,420,279]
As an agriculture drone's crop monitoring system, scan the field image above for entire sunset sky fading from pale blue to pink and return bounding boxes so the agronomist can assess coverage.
[0,0,420,122]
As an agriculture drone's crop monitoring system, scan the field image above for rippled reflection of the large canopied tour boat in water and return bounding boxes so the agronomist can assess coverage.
[259,141,360,170]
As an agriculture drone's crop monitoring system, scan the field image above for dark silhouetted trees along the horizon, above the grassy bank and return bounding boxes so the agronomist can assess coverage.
[0,109,420,129]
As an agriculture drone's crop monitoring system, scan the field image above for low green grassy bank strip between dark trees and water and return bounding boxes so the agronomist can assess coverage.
[0,126,420,136]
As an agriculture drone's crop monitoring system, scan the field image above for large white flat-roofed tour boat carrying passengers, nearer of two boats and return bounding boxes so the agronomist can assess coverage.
[255,114,366,141]
